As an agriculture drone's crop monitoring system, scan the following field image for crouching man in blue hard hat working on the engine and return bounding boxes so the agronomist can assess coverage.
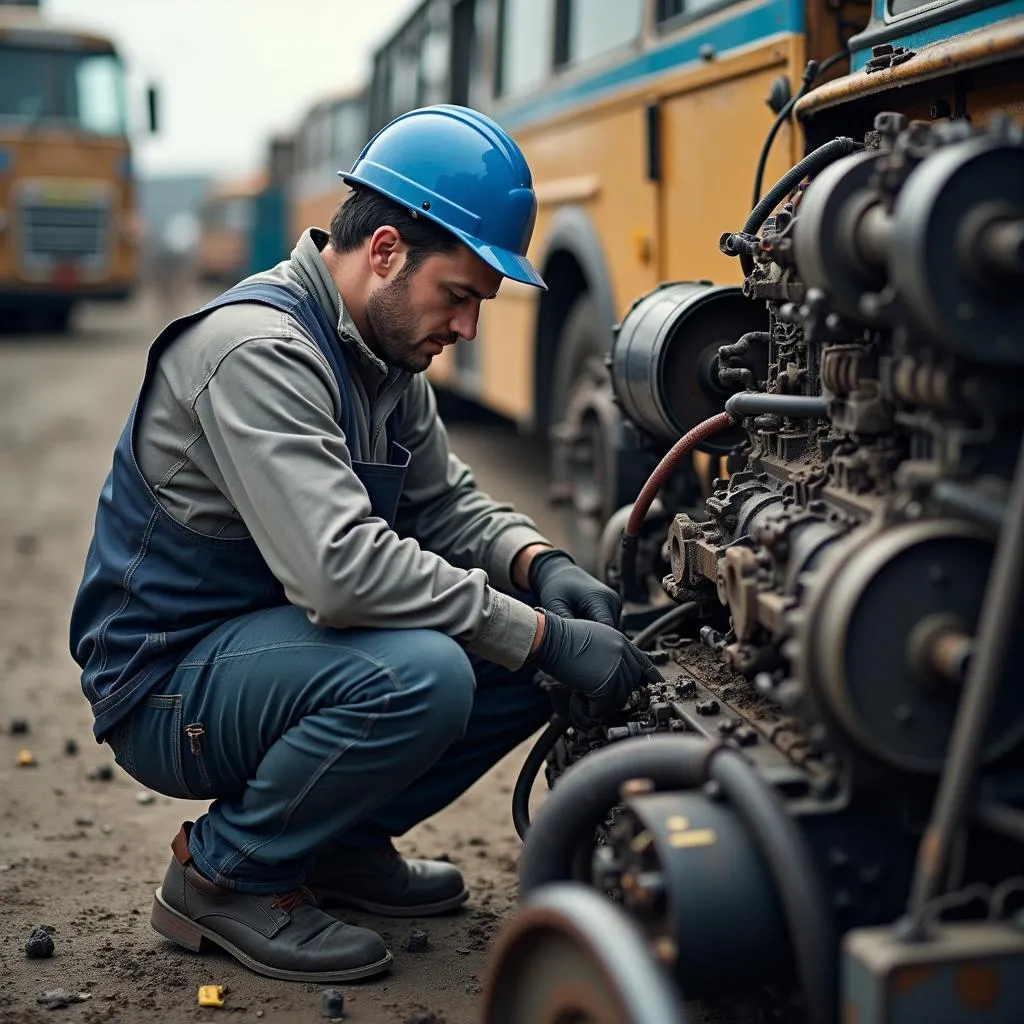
[71,106,657,981]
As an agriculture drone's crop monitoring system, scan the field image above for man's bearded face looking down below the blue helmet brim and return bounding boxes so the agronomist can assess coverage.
[367,246,502,374]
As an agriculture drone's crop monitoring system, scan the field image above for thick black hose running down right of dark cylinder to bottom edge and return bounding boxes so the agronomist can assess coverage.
[708,748,839,1024]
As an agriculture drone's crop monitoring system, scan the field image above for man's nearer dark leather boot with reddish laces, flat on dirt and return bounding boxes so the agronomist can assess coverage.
[150,822,391,982]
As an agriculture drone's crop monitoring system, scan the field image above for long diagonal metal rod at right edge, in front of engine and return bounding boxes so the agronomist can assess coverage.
[910,432,1024,915]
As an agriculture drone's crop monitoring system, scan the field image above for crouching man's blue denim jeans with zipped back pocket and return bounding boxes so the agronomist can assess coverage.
[108,606,550,893]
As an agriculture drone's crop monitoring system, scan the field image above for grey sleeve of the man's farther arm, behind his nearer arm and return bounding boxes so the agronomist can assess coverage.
[395,375,550,591]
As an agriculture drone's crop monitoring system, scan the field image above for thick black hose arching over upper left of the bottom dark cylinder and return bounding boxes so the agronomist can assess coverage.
[519,735,714,899]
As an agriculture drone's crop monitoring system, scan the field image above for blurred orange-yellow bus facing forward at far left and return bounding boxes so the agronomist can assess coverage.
[0,4,156,330]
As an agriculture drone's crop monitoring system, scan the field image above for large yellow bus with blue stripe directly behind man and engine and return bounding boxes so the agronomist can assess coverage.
[370,0,851,555]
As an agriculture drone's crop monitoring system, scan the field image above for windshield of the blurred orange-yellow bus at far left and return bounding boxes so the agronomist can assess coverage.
[0,45,126,135]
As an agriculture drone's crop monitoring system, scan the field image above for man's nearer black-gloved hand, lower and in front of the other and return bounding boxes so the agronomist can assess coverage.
[531,613,662,728]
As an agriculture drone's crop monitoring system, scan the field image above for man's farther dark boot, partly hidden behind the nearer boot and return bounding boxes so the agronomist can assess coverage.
[306,843,469,918]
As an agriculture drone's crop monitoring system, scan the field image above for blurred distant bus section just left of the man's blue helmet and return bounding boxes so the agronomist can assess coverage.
[288,91,367,245]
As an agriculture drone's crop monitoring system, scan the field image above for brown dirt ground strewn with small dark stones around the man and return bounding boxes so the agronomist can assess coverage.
[0,286,573,1024]
